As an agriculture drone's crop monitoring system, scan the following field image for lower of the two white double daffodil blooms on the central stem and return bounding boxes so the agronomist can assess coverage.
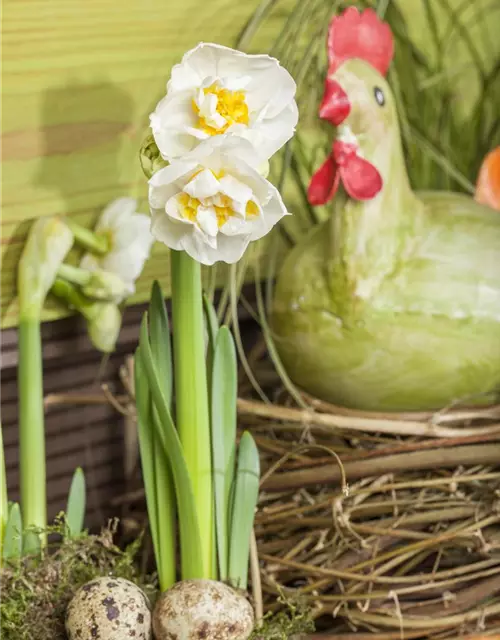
[149,136,287,265]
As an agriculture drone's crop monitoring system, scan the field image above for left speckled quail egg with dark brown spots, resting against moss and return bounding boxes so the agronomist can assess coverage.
[66,577,151,640]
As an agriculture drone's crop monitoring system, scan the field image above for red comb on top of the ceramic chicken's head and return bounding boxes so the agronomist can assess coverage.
[327,7,394,76]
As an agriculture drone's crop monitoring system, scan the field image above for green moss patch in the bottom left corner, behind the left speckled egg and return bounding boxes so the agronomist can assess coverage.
[0,524,156,640]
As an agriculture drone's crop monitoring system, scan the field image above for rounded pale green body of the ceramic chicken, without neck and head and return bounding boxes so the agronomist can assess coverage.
[272,188,500,411]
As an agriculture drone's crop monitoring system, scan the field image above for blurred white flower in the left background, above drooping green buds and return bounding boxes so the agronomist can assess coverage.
[80,198,154,297]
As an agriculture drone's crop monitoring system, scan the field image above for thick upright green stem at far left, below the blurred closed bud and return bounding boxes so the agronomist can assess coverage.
[18,315,47,544]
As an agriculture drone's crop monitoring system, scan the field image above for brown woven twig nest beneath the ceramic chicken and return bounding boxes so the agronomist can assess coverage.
[47,347,500,640]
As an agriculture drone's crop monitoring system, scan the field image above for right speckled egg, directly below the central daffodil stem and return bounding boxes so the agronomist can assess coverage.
[153,580,254,640]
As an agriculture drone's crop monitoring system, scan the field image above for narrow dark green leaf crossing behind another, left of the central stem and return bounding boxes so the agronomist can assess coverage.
[149,281,176,591]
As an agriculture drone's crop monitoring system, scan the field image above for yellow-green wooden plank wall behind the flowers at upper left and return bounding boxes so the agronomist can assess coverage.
[0,0,292,328]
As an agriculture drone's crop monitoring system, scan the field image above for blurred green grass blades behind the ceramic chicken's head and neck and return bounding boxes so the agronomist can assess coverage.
[239,0,500,242]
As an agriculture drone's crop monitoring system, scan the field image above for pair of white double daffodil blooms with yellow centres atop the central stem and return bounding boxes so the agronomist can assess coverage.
[149,44,298,265]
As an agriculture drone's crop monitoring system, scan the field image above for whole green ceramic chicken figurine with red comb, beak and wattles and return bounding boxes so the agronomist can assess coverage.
[271,8,500,411]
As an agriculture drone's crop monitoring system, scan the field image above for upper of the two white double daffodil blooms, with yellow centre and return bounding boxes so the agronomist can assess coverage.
[150,43,298,166]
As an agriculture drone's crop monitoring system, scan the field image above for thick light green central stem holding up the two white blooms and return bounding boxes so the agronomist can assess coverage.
[171,251,216,578]
